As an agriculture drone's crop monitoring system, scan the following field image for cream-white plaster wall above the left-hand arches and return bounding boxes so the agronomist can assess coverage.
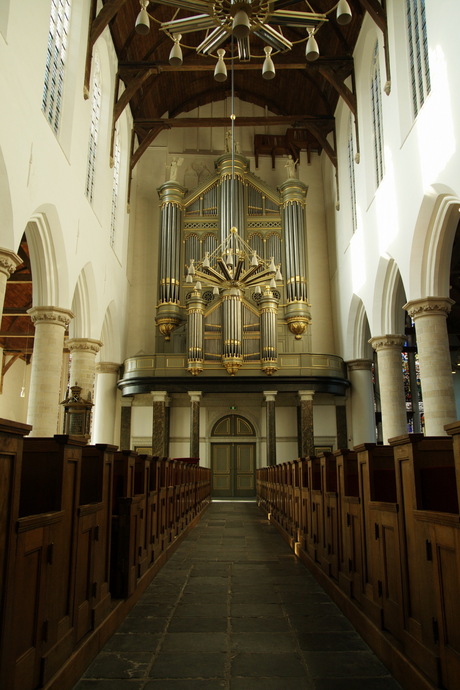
[0,0,131,421]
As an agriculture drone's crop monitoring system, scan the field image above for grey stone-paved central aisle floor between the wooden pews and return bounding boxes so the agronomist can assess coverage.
[75,502,400,690]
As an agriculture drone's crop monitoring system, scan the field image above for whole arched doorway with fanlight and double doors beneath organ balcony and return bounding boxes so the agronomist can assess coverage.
[211,414,256,498]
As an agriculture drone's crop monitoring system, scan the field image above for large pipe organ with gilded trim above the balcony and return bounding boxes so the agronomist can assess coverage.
[156,153,311,376]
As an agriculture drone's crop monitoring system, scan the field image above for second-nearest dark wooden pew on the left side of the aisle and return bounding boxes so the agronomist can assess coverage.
[6,435,85,690]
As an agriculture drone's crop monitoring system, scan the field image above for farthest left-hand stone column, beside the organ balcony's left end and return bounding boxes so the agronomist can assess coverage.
[92,362,120,445]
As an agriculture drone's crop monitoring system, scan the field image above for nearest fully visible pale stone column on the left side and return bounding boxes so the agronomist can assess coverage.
[27,307,73,436]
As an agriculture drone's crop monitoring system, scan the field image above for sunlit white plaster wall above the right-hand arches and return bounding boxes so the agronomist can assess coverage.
[324,0,460,359]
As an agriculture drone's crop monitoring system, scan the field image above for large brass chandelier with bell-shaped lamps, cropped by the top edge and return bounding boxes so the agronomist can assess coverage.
[135,0,352,81]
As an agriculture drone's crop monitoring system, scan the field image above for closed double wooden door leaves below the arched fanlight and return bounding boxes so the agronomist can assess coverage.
[211,443,256,498]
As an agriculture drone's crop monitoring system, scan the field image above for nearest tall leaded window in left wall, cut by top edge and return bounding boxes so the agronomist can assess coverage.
[42,0,71,134]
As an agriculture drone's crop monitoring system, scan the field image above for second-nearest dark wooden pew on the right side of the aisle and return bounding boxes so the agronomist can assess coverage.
[389,434,460,690]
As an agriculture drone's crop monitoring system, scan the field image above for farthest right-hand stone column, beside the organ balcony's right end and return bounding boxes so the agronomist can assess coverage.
[347,359,376,446]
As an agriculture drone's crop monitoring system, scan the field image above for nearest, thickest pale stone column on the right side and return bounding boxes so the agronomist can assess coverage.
[404,297,457,436]
